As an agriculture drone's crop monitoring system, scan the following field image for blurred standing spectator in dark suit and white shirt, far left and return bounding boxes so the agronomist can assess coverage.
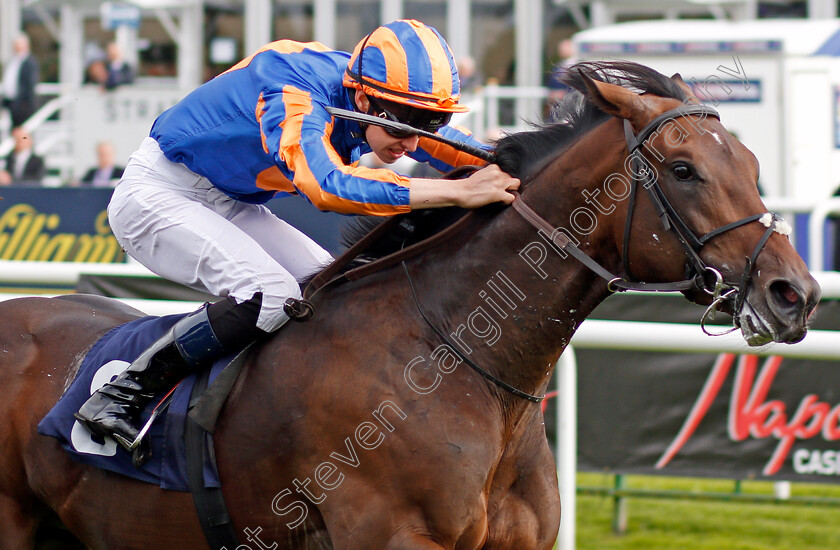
[0,34,41,127]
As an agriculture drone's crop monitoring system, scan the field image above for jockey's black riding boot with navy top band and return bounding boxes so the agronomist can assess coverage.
[75,307,229,451]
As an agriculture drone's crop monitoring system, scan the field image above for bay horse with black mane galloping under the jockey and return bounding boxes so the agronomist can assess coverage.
[0,62,819,550]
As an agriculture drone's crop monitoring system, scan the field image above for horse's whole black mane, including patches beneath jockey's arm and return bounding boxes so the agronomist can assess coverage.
[312,61,686,278]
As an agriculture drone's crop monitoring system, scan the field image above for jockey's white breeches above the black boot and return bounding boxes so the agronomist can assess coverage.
[108,138,332,332]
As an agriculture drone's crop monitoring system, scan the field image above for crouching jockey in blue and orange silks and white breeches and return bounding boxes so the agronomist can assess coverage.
[76,20,519,450]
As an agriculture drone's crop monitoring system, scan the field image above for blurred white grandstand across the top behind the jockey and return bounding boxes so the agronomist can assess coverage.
[0,0,837,186]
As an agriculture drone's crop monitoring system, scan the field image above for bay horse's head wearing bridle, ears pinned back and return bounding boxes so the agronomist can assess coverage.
[578,64,820,346]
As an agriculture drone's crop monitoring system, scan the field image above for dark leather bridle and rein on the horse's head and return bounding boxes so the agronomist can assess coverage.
[512,104,789,336]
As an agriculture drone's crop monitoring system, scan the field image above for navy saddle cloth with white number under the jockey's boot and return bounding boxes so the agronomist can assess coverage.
[38,315,232,491]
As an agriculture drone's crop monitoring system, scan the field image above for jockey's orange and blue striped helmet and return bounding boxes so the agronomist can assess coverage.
[344,19,469,113]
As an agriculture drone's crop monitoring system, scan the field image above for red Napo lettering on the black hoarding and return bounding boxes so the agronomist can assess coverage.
[656,354,840,476]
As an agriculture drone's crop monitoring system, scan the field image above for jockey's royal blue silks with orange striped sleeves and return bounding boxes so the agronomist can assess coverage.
[150,40,486,216]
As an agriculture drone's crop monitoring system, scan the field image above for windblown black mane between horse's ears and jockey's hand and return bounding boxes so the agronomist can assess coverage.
[496,61,686,178]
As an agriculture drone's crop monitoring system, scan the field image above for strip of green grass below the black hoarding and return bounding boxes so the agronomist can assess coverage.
[577,474,840,550]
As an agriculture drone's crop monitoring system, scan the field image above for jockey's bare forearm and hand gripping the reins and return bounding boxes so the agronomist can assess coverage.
[409,164,519,210]
